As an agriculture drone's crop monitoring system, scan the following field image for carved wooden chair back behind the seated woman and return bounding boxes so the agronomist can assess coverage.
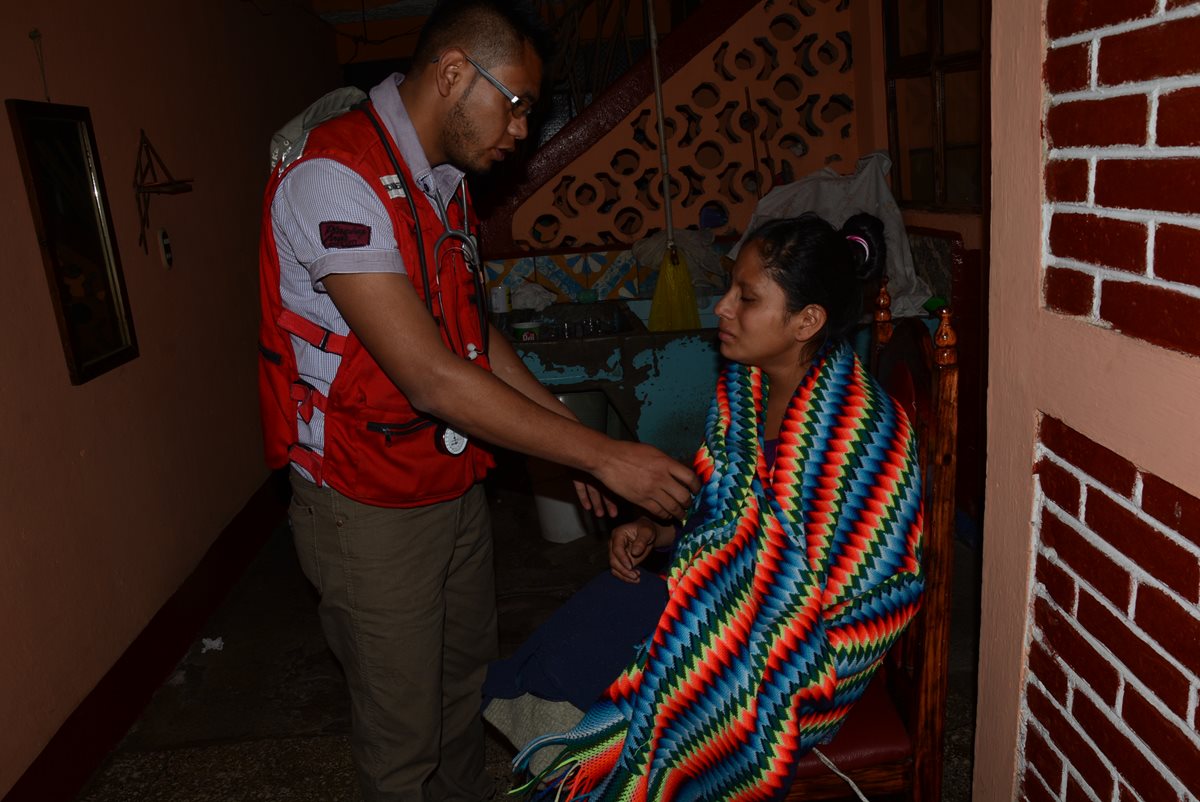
[869,279,958,801]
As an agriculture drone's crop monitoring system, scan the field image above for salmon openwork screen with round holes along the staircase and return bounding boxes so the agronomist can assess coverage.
[512,0,859,251]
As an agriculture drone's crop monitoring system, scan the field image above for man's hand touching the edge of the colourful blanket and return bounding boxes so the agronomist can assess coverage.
[593,441,700,519]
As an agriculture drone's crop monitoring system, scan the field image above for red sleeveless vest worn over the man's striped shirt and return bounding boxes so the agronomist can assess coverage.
[258,109,494,507]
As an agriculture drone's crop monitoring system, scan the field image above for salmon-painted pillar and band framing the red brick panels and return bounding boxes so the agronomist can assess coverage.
[974,0,1200,802]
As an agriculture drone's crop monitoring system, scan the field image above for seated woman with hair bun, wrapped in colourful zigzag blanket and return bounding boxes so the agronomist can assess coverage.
[487,215,923,802]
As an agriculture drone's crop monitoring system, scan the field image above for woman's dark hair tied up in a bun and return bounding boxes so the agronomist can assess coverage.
[742,213,887,341]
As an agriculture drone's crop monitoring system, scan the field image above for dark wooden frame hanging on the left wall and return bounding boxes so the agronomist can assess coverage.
[5,100,138,384]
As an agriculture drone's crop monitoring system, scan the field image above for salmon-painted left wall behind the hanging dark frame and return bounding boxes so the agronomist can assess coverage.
[0,0,338,795]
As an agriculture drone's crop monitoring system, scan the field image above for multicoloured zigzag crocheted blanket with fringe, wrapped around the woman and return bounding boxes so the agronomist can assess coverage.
[514,343,923,802]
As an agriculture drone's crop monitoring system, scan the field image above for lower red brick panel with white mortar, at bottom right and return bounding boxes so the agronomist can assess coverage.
[1021,417,1200,802]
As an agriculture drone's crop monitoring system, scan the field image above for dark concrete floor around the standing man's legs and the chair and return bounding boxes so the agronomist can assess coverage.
[77,462,979,802]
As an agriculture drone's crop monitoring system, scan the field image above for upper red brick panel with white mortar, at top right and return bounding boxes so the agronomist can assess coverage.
[1043,0,1200,354]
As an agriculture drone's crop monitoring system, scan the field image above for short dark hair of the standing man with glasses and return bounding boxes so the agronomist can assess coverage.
[413,0,551,68]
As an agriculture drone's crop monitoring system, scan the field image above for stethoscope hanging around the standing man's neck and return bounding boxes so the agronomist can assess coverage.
[360,102,490,456]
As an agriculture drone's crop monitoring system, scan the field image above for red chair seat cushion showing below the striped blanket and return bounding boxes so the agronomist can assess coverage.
[796,671,912,777]
